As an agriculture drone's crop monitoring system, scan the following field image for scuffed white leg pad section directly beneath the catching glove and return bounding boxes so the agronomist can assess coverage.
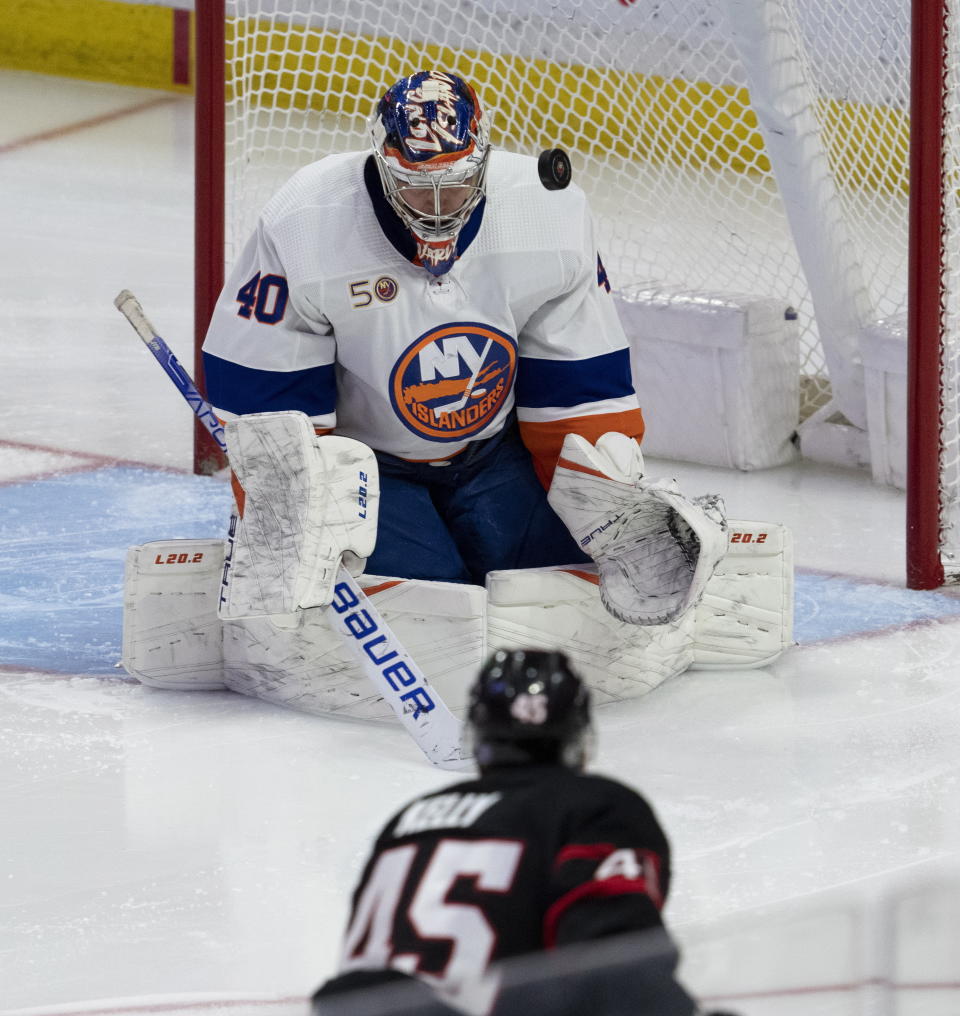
[487,565,694,702]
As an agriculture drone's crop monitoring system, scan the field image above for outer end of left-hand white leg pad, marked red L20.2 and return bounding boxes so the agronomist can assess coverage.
[120,539,227,691]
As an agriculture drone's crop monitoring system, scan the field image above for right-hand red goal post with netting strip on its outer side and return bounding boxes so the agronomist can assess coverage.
[906,0,960,589]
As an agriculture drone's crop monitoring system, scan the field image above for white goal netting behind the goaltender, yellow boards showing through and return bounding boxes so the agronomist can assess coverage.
[217,0,957,581]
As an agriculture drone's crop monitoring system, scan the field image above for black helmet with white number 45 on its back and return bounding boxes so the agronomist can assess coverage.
[467,649,592,769]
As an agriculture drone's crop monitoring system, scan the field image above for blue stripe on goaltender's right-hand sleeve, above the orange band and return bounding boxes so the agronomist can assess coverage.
[515,350,634,409]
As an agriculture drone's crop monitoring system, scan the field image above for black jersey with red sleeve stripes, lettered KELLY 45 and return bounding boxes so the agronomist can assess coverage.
[341,765,670,985]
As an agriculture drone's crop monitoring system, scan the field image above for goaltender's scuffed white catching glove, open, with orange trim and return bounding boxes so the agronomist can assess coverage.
[548,432,727,625]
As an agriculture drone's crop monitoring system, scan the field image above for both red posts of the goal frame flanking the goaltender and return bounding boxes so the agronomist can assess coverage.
[193,0,948,589]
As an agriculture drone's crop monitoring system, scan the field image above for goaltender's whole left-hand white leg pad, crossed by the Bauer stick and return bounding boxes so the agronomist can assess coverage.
[121,539,487,723]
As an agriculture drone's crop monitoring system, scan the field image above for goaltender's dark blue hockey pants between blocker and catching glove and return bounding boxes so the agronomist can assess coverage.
[366,420,589,585]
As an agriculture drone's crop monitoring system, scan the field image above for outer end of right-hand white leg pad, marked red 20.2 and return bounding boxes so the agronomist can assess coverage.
[693,520,793,670]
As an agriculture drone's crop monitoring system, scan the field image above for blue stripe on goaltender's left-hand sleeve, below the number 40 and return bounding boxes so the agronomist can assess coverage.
[203,353,336,417]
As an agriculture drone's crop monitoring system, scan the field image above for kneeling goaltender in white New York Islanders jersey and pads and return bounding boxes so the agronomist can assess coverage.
[116,71,792,767]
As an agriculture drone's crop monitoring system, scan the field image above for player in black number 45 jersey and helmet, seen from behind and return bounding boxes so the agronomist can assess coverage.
[313,650,696,1016]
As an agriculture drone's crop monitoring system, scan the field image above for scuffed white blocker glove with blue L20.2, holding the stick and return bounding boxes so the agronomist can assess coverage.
[220,412,379,620]
